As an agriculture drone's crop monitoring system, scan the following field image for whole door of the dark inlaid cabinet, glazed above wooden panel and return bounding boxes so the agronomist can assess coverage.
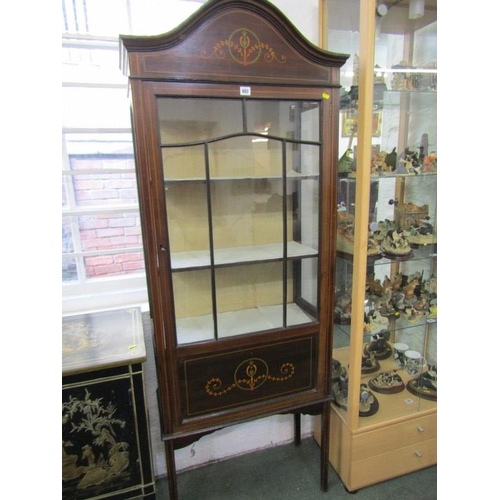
[130,82,335,432]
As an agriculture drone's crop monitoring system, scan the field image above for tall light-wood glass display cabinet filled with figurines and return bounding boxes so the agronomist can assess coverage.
[316,0,437,491]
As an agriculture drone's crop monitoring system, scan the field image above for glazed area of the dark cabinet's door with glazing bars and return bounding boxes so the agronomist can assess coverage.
[157,97,321,345]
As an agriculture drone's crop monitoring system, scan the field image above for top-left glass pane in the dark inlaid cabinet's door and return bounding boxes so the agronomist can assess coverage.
[158,97,243,144]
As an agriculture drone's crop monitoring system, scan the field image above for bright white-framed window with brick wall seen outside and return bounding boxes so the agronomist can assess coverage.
[61,0,204,313]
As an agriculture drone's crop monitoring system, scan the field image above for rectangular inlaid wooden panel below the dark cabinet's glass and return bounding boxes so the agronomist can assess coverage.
[179,335,317,417]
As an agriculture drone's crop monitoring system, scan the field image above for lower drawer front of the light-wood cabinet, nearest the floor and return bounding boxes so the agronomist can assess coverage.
[349,438,437,490]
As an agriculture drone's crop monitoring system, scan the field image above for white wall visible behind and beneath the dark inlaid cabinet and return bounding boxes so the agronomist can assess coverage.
[144,0,319,477]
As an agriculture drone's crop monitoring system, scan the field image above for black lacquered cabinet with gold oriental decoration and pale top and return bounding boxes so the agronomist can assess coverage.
[62,308,155,500]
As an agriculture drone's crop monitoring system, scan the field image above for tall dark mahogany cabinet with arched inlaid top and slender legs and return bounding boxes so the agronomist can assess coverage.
[121,0,347,499]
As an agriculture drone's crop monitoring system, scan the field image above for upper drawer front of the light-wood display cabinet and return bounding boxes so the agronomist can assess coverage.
[352,414,437,462]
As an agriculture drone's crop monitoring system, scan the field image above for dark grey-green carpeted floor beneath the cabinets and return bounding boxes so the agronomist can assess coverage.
[156,437,437,500]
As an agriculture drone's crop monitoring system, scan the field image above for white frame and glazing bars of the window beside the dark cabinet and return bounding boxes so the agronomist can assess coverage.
[61,0,211,314]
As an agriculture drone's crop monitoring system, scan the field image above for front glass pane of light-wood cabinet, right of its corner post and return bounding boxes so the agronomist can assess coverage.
[367,6,437,419]
